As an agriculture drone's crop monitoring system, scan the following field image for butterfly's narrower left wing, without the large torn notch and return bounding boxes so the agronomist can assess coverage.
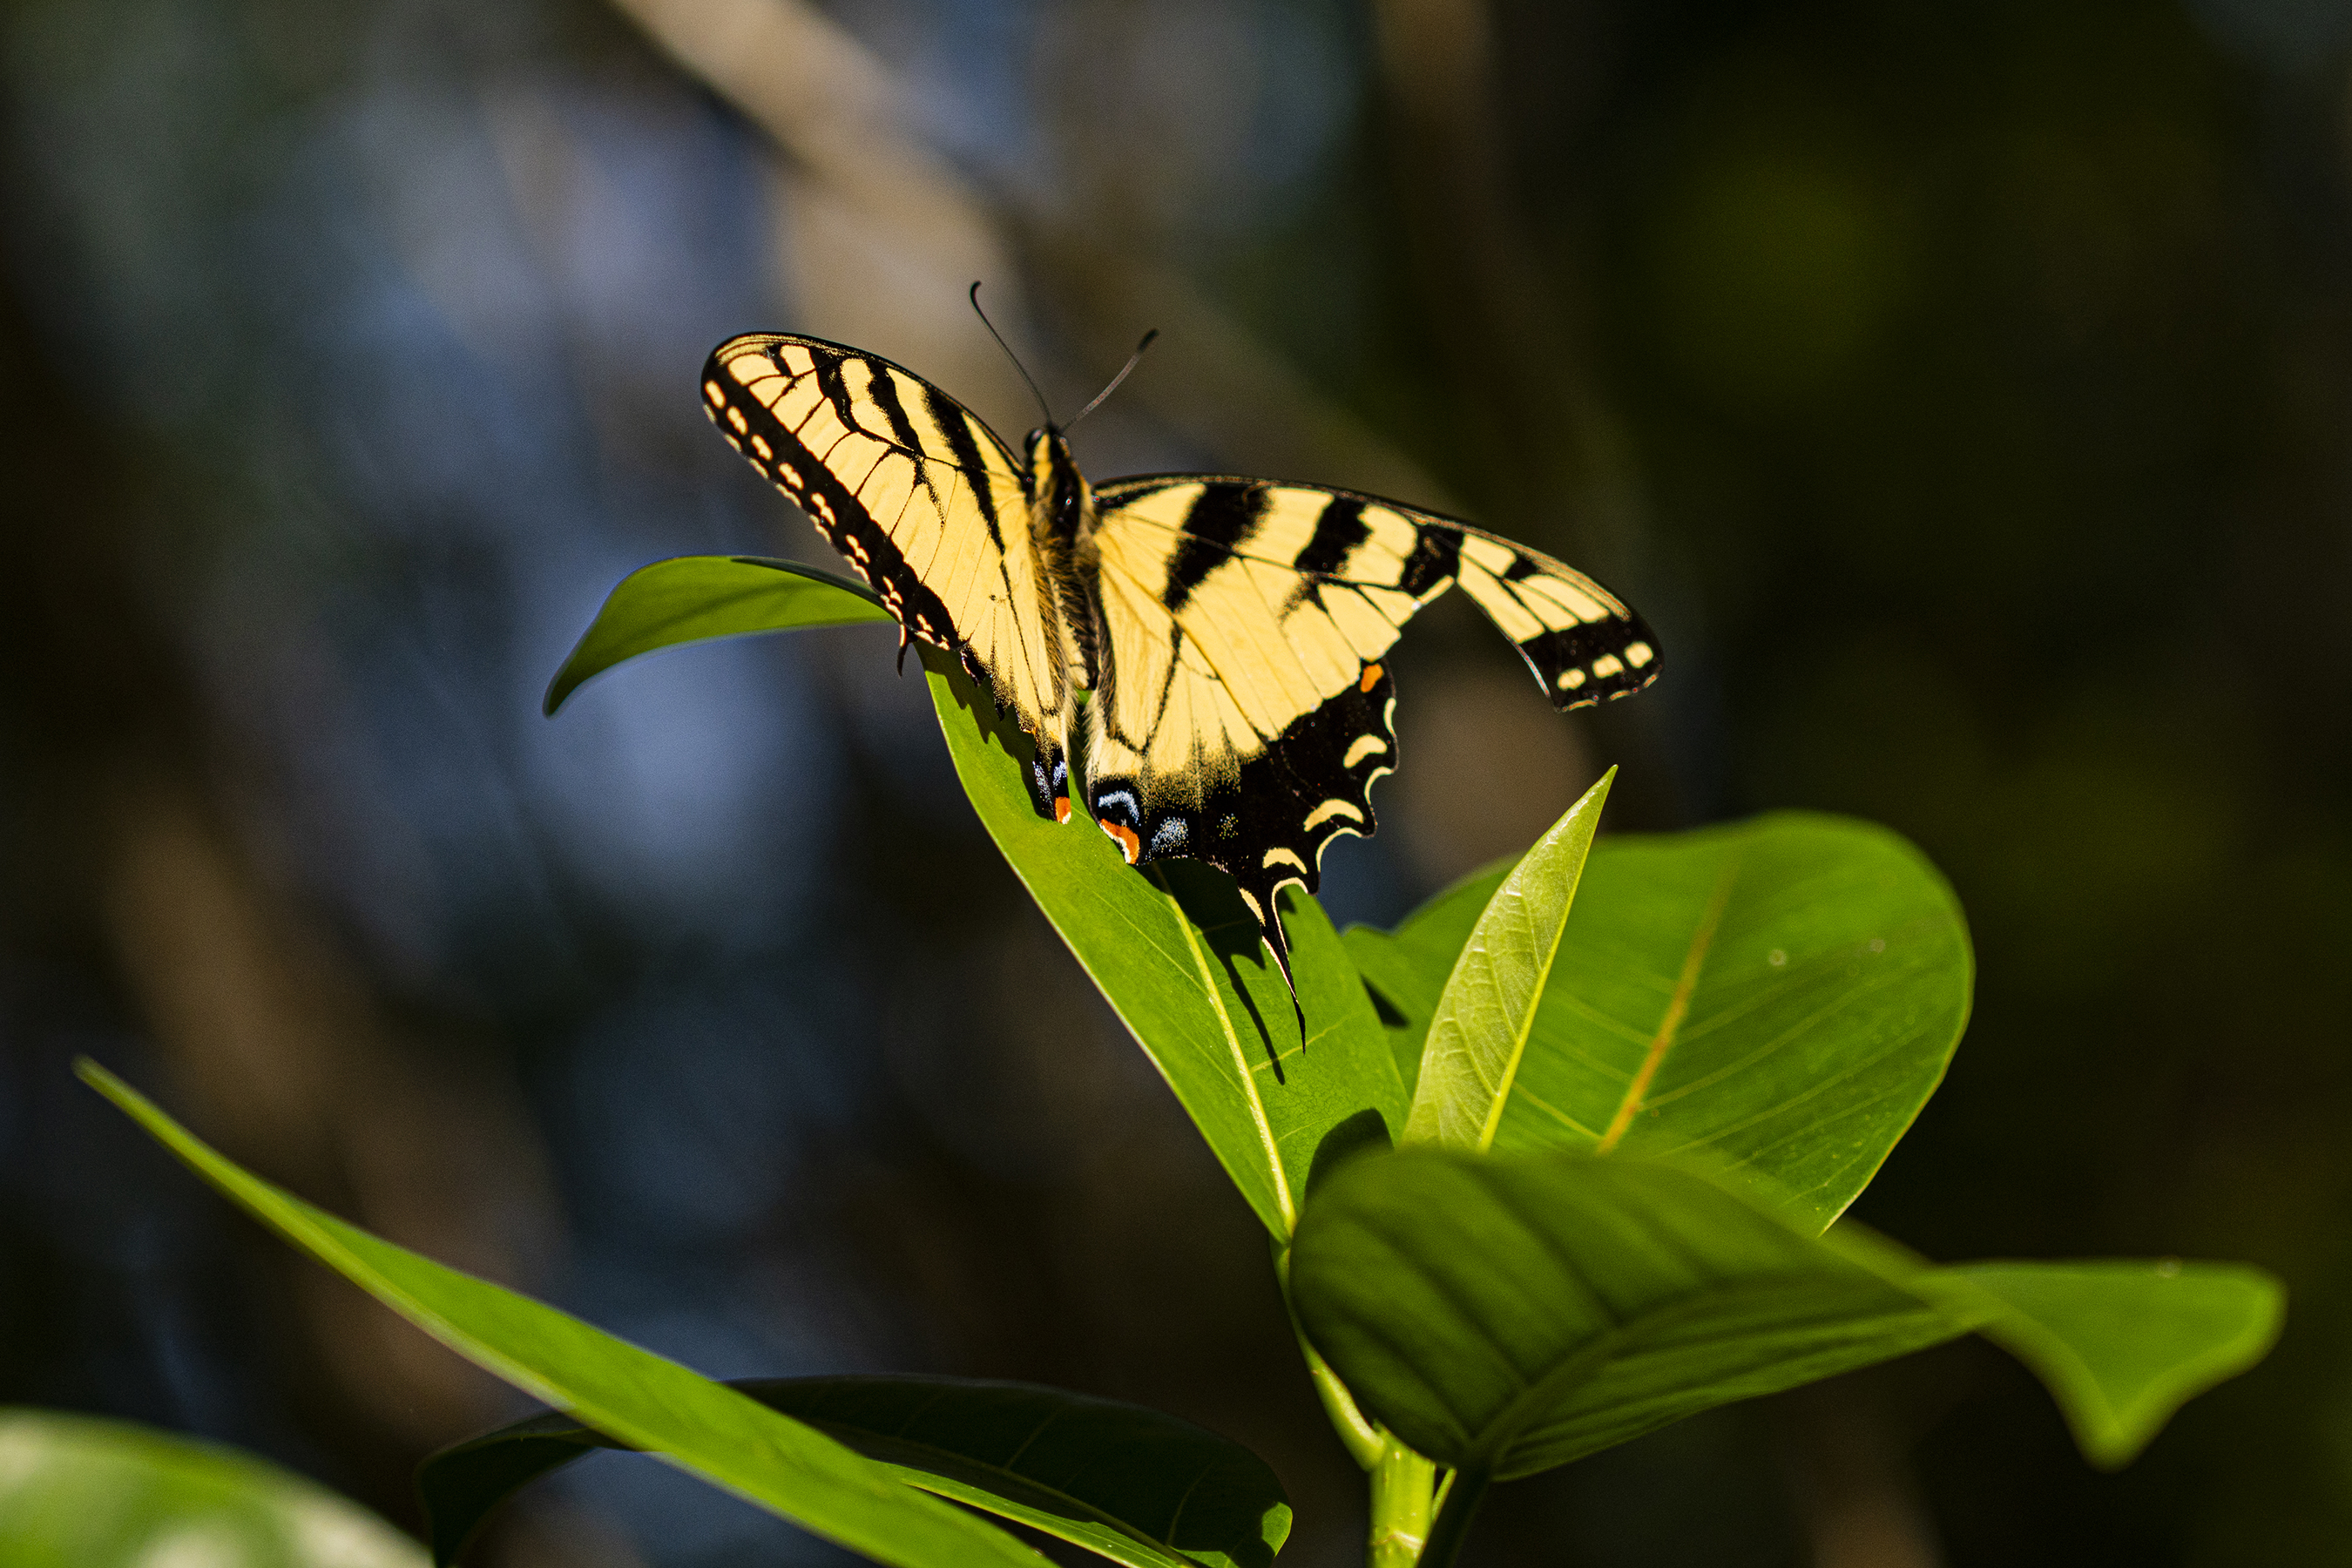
[703,332,1075,818]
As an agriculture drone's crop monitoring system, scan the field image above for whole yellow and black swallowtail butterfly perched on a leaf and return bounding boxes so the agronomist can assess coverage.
[703,332,1659,995]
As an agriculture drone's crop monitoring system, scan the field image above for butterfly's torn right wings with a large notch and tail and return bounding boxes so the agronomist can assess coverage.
[1086,475,1659,973]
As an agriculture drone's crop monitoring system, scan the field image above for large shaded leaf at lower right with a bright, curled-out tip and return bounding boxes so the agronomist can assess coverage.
[1291,1150,2279,1478]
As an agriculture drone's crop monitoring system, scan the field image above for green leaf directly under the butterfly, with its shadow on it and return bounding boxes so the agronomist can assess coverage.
[924,649,1404,1241]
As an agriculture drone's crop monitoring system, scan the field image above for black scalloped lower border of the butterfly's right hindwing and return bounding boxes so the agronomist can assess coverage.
[1089,663,1397,999]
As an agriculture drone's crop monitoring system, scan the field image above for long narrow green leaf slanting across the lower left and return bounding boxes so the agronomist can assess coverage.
[78,1060,1044,1568]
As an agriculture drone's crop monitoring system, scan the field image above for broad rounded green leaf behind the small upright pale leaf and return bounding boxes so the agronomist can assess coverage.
[1345,814,1973,1229]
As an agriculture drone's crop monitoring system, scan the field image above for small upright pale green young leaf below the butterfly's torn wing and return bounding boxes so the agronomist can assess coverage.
[1404,768,1616,1152]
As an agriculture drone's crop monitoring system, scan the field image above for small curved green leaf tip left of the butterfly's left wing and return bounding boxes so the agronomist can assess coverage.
[545,555,891,714]
